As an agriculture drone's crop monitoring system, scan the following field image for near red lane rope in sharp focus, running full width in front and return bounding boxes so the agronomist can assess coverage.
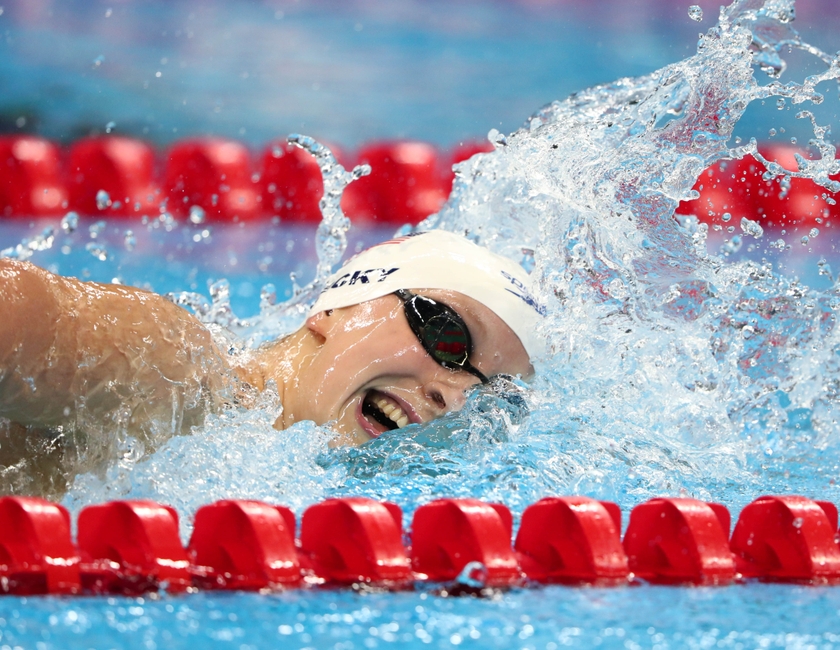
[0,496,840,595]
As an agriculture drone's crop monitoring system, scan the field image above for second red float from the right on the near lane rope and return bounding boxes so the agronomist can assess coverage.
[624,499,735,585]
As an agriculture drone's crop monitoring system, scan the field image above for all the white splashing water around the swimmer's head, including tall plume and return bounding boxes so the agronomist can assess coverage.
[59,0,840,512]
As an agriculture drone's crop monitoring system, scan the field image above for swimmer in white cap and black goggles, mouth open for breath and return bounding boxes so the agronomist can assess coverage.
[0,231,539,493]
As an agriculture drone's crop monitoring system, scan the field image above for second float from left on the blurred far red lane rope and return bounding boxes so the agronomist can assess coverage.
[68,136,162,216]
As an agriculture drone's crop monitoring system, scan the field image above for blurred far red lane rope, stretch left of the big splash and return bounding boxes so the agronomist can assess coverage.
[0,136,492,224]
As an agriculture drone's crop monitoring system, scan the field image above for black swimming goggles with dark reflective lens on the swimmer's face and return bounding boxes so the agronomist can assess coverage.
[394,289,489,384]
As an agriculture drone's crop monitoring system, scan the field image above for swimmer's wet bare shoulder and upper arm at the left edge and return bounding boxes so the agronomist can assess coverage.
[0,259,227,433]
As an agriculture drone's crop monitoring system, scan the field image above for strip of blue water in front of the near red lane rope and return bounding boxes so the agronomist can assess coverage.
[0,585,840,650]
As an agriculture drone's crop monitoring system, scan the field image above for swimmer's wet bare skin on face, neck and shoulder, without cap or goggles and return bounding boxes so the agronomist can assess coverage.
[0,259,532,495]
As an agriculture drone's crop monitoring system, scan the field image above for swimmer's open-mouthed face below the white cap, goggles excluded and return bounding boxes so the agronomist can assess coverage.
[284,290,533,445]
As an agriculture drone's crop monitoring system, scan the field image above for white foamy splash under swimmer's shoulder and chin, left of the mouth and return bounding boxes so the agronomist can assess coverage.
[64,390,344,538]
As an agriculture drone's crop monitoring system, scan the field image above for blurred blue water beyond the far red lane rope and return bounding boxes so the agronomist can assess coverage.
[0,0,840,148]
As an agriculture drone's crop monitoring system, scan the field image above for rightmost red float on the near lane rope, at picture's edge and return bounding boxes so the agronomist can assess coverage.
[731,496,840,582]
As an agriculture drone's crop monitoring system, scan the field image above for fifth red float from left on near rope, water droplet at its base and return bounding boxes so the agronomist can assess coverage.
[411,499,522,587]
